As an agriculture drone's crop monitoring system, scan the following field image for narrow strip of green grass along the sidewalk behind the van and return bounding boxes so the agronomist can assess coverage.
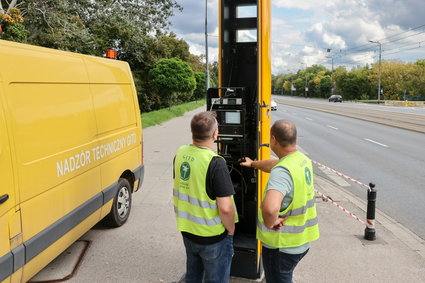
[142,99,205,129]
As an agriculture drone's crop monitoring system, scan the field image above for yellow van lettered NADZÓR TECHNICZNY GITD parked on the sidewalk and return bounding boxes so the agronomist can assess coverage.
[0,40,144,282]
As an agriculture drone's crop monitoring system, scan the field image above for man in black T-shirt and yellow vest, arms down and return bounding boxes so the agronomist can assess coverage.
[173,111,237,283]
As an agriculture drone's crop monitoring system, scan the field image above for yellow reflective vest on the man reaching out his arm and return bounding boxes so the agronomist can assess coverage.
[257,151,319,248]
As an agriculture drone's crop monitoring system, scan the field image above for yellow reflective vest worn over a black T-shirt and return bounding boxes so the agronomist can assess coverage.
[173,145,237,237]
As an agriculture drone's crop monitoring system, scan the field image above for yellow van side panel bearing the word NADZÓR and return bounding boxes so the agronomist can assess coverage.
[6,83,97,201]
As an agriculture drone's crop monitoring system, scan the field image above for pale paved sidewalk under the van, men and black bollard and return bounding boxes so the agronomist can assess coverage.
[30,107,425,283]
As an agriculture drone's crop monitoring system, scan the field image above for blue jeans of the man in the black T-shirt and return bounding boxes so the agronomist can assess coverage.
[183,235,233,283]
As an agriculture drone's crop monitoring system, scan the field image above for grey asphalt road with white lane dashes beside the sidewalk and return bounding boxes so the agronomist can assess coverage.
[272,100,425,242]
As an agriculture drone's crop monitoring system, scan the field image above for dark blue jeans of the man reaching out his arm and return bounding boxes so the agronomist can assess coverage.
[263,246,308,283]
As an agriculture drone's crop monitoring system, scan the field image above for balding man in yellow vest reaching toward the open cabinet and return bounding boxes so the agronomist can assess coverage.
[241,120,319,283]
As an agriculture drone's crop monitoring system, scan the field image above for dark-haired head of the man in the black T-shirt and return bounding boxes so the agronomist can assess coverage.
[190,111,217,141]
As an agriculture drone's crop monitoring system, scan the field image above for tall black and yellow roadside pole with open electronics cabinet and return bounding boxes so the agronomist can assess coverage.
[207,0,271,278]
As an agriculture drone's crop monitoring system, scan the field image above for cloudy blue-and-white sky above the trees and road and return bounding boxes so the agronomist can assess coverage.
[170,0,425,74]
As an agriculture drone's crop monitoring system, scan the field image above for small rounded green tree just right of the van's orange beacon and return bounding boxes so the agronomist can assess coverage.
[149,58,196,106]
